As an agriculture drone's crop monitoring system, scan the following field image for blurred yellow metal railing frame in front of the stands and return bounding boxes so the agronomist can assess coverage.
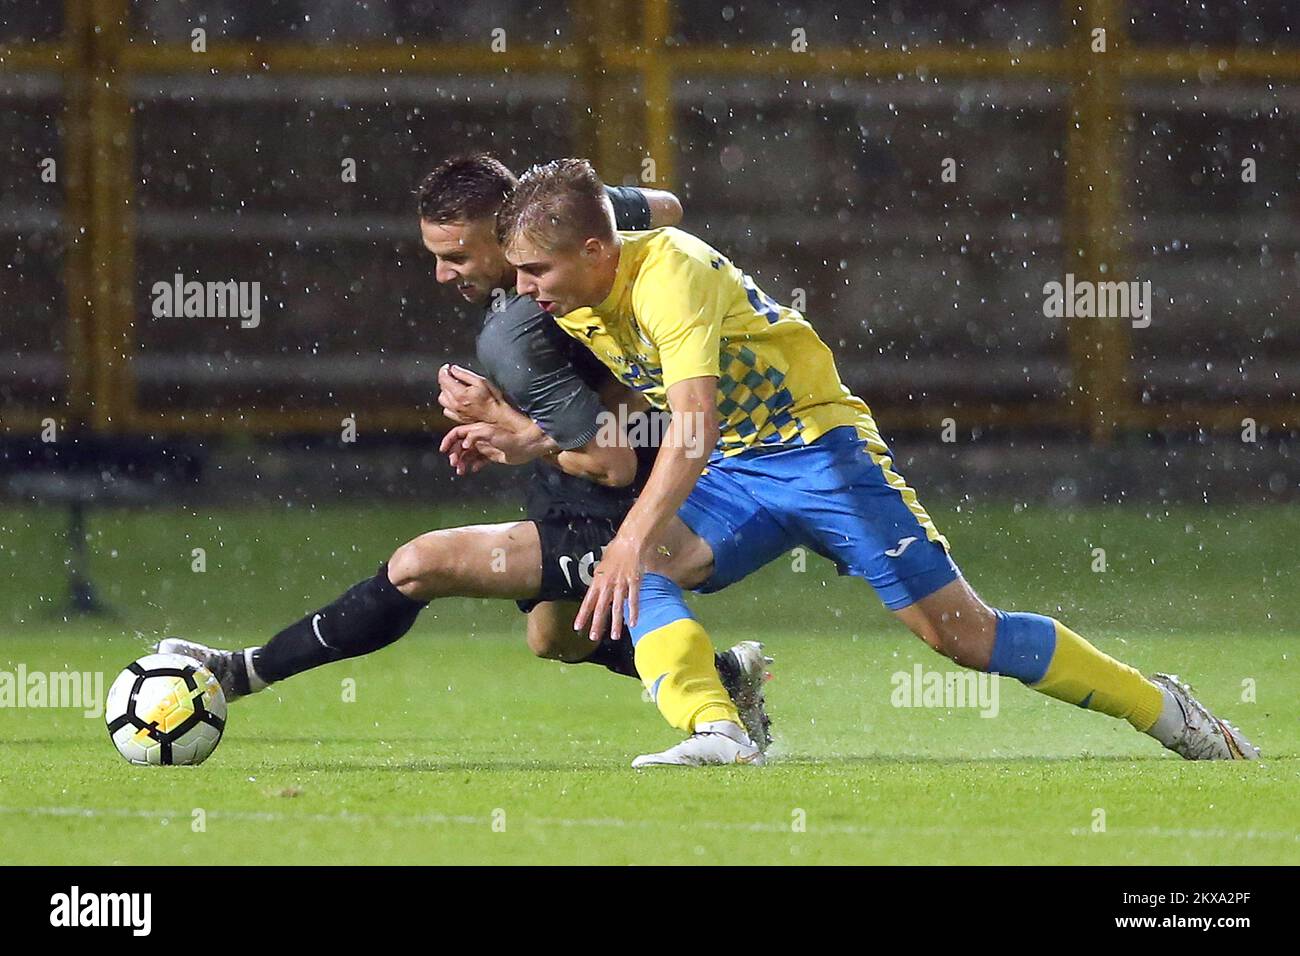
[0,0,1300,442]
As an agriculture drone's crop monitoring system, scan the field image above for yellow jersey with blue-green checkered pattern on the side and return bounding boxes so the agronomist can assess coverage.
[556,226,878,455]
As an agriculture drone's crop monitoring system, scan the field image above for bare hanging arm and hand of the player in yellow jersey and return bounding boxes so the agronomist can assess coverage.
[573,376,720,640]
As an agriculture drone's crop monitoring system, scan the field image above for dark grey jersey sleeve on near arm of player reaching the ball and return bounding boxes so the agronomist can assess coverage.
[478,300,603,451]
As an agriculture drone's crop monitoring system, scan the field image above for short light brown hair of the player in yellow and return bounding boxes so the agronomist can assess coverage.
[497,159,614,251]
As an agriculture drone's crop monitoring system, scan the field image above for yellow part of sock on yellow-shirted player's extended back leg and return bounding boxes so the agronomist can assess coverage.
[1030,620,1165,731]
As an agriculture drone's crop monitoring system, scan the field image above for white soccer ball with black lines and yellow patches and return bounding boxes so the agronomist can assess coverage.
[104,654,226,766]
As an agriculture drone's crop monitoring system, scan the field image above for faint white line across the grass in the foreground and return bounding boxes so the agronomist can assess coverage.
[0,806,1300,843]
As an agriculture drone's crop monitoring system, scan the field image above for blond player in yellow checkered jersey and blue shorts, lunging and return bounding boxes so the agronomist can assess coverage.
[488,160,1258,766]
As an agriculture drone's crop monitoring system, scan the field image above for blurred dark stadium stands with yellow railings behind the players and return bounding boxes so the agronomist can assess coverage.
[0,0,1300,580]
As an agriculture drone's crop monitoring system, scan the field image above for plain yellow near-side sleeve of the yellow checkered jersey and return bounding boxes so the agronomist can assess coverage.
[632,250,727,390]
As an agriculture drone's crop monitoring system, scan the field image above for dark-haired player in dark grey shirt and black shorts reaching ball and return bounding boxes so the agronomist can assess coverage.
[159,155,770,744]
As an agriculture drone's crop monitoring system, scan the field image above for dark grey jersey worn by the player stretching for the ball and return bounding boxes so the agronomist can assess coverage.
[477,186,655,519]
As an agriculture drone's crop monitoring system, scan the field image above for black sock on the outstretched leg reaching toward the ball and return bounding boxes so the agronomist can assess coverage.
[252,564,431,684]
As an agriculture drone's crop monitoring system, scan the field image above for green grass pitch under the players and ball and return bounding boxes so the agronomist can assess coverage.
[0,503,1300,864]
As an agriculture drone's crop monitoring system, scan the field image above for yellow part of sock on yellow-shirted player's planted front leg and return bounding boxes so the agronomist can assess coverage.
[636,618,740,734]
